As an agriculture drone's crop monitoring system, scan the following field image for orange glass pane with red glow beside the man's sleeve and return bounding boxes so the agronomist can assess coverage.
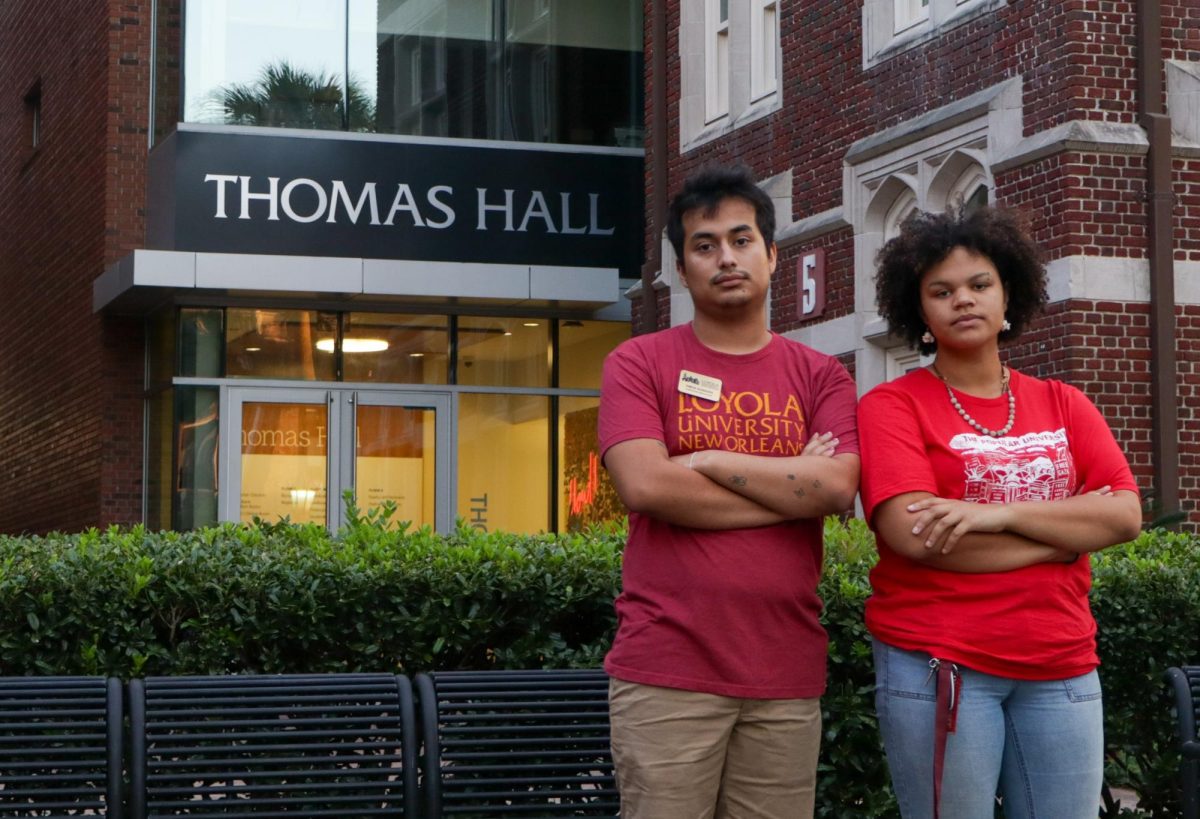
[558,396,625,532]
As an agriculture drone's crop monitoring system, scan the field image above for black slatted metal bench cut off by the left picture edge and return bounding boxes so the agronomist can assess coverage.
[0,677,124,819]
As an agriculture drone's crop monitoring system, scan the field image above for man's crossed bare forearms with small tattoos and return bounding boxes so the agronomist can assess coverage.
[604,434,859,530]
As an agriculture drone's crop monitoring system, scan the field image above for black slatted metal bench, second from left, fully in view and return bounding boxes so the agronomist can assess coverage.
[130,674,416,819]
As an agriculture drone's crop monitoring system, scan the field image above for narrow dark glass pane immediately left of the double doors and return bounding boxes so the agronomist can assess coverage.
[172,387,220,530]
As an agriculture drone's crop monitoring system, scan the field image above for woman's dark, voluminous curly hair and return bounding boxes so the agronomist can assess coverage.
[875,205,1046,355]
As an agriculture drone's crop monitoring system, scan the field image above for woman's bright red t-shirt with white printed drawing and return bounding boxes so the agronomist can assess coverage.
[858,369,1138,680]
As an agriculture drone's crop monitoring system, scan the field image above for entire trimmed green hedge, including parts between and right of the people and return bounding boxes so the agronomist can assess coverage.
[0,515,1200,819]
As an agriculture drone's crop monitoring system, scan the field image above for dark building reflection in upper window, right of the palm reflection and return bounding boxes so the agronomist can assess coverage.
[372,0,642,148]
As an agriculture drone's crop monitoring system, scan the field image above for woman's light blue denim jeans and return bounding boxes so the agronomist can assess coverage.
[875,640,1104,819]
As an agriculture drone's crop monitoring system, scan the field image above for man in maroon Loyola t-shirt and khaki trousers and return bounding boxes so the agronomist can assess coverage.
[600,167,859,819]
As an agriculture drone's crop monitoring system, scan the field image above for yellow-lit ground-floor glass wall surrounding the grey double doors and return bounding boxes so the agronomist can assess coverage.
[159,307,629,532]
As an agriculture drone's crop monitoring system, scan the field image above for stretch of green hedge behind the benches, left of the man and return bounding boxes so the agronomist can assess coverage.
[0,516,622,677]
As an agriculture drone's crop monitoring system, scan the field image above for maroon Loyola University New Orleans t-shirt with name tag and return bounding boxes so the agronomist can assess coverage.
[599,324,858,699]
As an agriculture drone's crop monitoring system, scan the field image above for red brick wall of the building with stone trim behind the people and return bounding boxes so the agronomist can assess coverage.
[646,0,1200,525]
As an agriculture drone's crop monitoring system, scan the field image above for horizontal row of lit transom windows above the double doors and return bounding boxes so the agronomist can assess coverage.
[178,307,629,389]
